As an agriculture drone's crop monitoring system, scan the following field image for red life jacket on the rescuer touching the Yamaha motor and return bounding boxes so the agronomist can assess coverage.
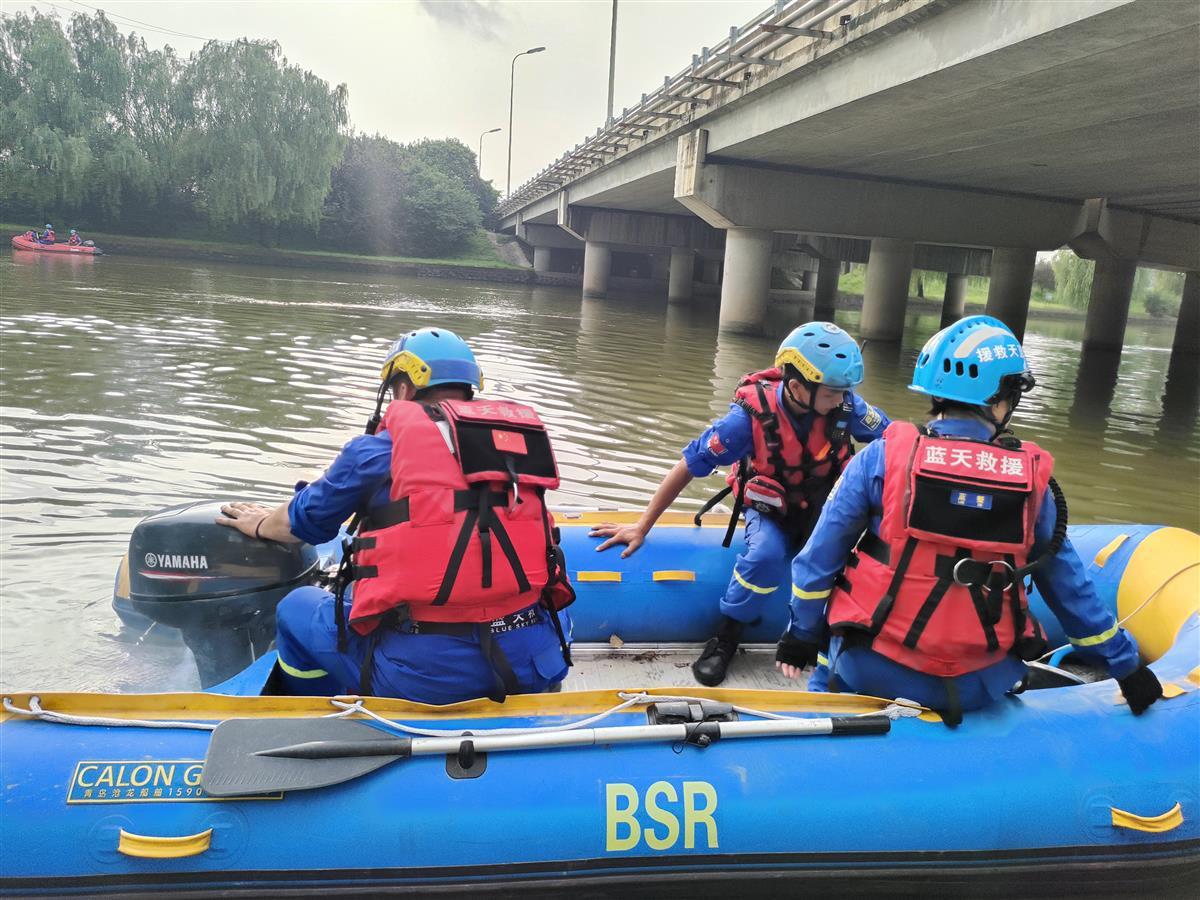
[350,400,575,635]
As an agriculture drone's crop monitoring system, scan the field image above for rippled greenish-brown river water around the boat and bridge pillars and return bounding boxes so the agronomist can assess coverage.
[0,253,1200,690]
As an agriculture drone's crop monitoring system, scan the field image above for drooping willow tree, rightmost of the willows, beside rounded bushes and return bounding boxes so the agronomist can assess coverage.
[184,41,347,236]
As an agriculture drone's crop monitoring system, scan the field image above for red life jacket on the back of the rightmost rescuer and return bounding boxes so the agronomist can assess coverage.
[828,422,1054,678]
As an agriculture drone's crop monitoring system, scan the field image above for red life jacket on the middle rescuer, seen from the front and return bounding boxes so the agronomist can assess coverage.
[726,368,853,520]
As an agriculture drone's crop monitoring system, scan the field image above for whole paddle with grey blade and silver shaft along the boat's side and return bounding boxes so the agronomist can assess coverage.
[200,715,892,797]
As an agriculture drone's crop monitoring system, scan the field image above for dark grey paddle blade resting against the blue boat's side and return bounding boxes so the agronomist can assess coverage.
[200,719,409,797]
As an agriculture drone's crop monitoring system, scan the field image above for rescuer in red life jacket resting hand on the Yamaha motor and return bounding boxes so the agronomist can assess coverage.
[217,328,575,703]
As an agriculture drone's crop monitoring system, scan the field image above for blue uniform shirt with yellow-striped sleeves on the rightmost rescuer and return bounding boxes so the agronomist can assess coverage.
[788,419,1138,678]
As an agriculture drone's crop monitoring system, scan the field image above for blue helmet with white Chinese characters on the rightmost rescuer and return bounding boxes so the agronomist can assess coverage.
[908,316,1034,406]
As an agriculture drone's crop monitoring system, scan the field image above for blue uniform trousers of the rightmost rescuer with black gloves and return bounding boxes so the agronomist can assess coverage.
[809,636,1025,712]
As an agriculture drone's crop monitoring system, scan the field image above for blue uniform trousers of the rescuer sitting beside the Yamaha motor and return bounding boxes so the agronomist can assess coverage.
[276,587,571,704]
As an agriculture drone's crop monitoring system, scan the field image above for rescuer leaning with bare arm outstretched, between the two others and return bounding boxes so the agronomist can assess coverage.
[592,322,889,685]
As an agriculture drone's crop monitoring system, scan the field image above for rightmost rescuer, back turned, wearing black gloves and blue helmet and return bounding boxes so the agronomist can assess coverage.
[775,316,1163,725]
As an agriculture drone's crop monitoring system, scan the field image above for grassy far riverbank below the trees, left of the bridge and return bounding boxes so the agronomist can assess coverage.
[0,223,522,272]
